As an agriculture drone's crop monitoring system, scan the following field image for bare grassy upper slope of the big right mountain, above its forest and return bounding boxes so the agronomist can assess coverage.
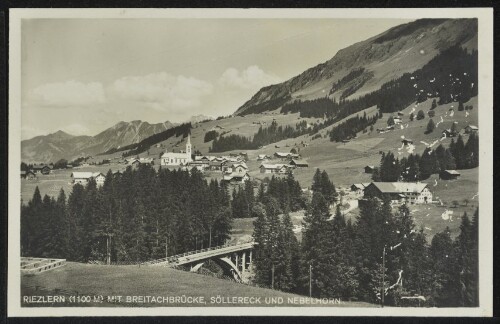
[235,19,477,115]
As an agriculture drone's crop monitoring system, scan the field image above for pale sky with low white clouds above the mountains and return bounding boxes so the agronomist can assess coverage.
[21,18,408,139]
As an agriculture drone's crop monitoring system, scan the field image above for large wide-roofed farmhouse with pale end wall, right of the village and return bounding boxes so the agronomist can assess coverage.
[364,182,432,204]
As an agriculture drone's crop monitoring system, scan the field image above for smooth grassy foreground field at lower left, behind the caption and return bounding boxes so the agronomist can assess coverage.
[21,262,376,307]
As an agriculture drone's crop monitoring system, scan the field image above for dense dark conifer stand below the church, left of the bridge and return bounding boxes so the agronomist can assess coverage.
[21,165,232,262]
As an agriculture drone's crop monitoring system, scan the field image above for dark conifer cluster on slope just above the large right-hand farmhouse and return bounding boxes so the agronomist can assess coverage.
[372,133,479,182]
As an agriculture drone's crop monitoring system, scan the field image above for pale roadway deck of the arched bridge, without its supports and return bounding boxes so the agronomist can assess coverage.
[144,242,254,266]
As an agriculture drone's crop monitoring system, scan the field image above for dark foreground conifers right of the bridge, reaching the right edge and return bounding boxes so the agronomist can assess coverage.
[252,170,479,307]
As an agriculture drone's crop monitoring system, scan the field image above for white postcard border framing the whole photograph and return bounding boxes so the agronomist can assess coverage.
[7,8,493,317]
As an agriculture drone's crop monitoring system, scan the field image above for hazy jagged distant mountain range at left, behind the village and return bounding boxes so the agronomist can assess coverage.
[21,120,176,163]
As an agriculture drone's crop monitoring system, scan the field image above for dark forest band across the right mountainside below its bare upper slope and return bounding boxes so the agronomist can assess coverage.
[281,46,478,120]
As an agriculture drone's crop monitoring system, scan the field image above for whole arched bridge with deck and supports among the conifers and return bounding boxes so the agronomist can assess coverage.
[143,241,255,281]
